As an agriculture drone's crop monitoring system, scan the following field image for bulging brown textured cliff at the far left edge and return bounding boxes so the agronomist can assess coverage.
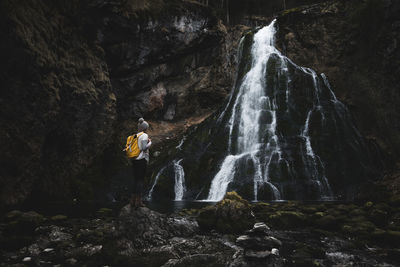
[0,1,116,203]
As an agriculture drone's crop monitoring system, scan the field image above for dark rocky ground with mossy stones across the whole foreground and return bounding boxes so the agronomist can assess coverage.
[0,193,400,266]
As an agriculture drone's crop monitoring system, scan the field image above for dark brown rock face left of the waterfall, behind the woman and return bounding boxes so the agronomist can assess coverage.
[0,0,242,204]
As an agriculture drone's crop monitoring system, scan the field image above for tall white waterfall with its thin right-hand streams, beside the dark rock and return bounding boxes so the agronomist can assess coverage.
[207,20,336,201]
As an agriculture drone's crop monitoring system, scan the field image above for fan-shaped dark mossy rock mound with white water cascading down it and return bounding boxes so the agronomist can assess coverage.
[152,21,380,201]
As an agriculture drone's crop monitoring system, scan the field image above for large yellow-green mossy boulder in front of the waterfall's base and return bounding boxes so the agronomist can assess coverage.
[197,192,255,234]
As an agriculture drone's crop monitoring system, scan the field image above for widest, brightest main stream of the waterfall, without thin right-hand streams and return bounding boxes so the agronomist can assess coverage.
[207,22,280,201]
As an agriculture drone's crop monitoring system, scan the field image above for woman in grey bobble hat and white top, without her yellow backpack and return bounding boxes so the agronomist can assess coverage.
[131,118,151,207]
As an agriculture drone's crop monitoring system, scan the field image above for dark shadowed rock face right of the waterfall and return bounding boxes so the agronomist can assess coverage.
[277,0,400,163]
